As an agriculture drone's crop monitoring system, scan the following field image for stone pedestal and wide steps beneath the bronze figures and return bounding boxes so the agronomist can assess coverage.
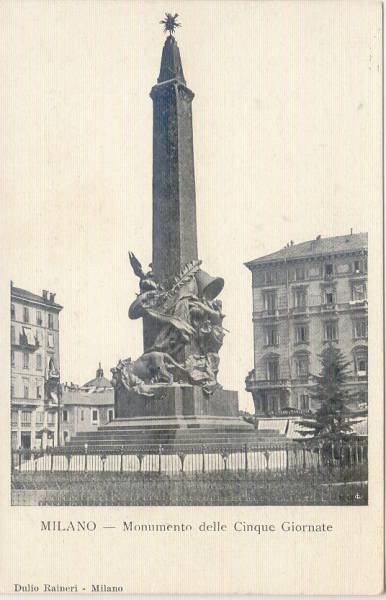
[67,384,285,449]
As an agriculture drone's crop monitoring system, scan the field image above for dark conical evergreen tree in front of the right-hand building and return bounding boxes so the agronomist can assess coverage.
[298,344,356,439]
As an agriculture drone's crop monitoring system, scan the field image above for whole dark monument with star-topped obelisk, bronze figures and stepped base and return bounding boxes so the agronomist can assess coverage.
[68,14,255,444]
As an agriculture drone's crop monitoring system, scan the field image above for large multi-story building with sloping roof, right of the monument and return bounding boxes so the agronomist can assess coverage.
[246,233,367,414]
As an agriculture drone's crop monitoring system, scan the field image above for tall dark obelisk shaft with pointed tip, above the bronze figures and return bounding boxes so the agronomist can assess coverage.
[150,35,197,282]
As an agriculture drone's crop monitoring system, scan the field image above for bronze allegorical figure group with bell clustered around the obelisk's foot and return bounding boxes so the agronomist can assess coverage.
[113,252,226,395]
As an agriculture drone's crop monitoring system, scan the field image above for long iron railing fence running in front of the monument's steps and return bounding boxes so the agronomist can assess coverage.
[11,440,368,475]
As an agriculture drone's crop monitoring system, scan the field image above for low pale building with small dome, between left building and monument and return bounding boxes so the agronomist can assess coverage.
[60,363,114,444]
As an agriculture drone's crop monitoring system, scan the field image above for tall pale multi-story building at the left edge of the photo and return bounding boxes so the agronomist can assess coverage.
[11,282,63,448]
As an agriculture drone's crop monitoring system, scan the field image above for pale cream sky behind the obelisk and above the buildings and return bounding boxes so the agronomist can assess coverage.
[1,1,381,409]
